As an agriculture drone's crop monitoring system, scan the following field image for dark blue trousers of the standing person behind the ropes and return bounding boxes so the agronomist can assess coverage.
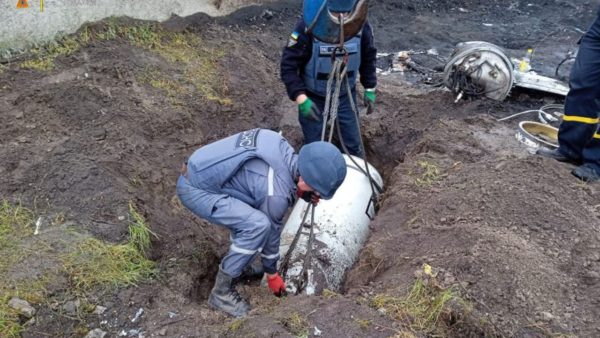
[298,90,363,157]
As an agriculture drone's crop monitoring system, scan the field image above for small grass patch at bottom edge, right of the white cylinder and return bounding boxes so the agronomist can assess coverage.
[371,279,464,334]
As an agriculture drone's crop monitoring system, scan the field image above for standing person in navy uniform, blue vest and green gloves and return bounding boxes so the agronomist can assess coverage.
[281,0,377,156]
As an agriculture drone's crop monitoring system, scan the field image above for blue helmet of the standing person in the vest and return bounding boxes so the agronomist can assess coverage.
[303,0,369,43]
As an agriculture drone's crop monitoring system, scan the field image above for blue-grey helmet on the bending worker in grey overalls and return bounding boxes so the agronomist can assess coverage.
[298,141,346,200]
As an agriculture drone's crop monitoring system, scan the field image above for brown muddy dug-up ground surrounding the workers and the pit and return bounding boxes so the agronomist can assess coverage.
[0,0,600,337]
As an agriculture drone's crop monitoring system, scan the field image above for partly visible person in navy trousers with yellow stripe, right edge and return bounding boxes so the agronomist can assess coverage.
[537,9,600,182]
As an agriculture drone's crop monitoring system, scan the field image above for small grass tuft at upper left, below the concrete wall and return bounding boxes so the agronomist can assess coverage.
[21,37,81,71]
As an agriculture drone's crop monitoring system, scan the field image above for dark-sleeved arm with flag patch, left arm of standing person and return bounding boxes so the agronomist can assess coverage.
[280,20,312,104]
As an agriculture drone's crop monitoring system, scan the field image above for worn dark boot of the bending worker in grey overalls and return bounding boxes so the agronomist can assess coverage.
[208,268,250,317]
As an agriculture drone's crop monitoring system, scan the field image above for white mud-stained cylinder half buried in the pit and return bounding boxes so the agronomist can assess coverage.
[279,155,383,295]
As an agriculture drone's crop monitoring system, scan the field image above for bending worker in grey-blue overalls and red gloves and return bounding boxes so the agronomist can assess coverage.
[177,129,346,317]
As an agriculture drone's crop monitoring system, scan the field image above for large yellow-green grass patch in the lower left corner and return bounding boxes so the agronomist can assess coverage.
[0,200,156,338]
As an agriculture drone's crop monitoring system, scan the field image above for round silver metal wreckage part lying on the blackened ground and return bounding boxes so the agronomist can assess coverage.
[444,41,515,101]
